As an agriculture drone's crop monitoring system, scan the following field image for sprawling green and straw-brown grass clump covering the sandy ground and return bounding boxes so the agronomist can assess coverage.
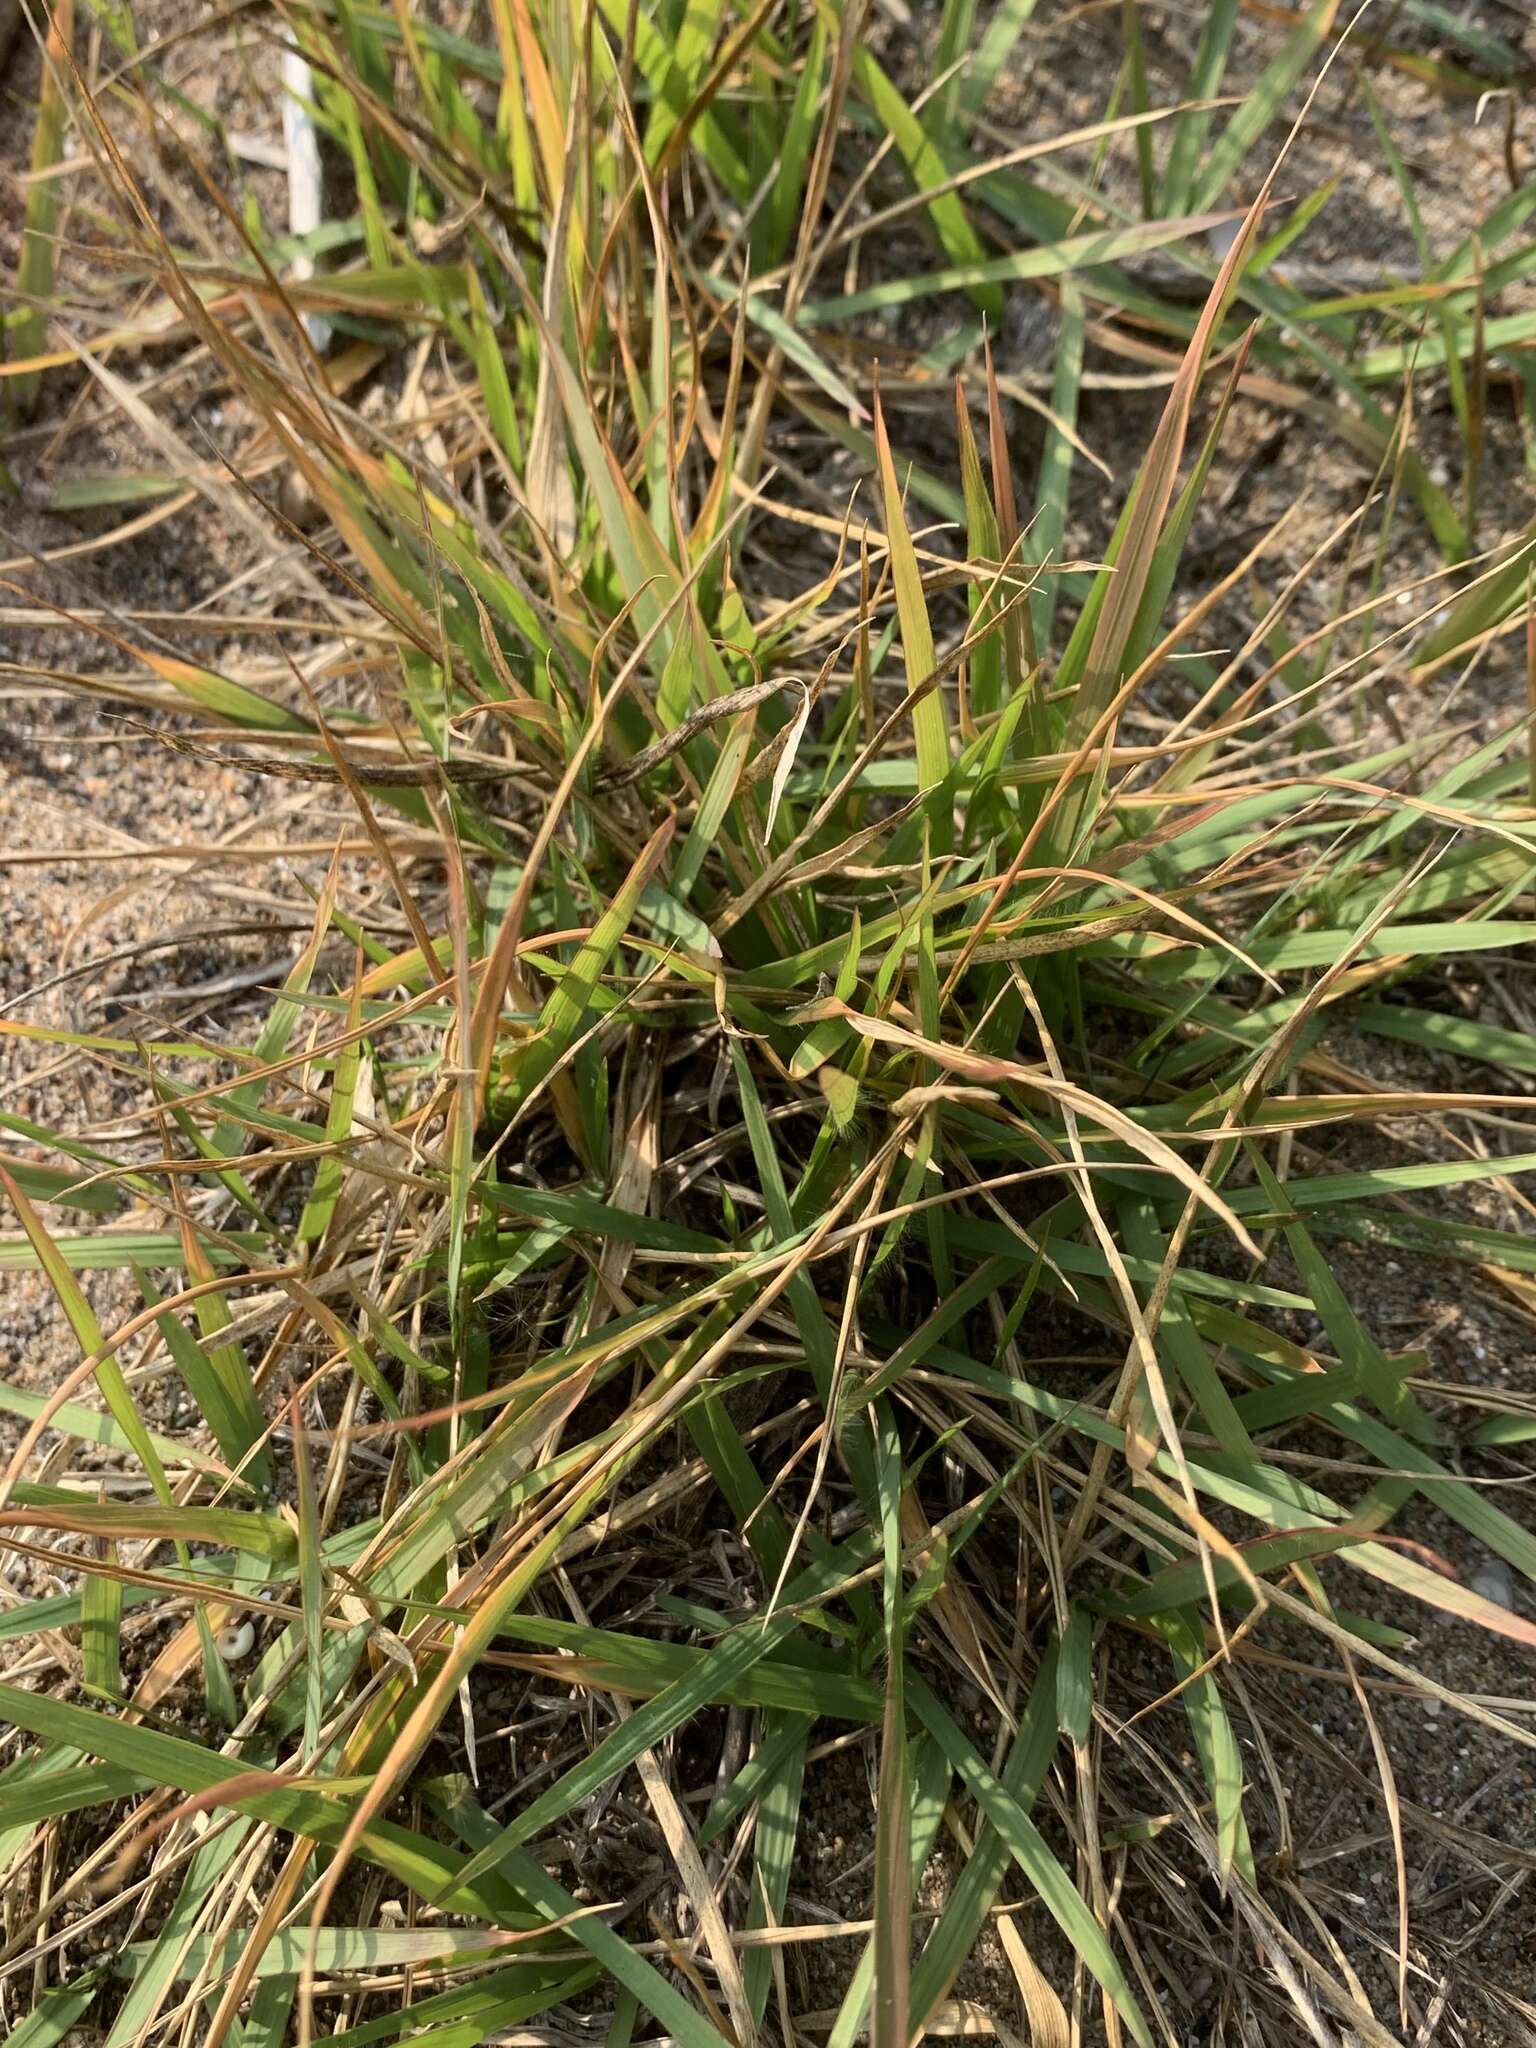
[0,0,1536,2048]
